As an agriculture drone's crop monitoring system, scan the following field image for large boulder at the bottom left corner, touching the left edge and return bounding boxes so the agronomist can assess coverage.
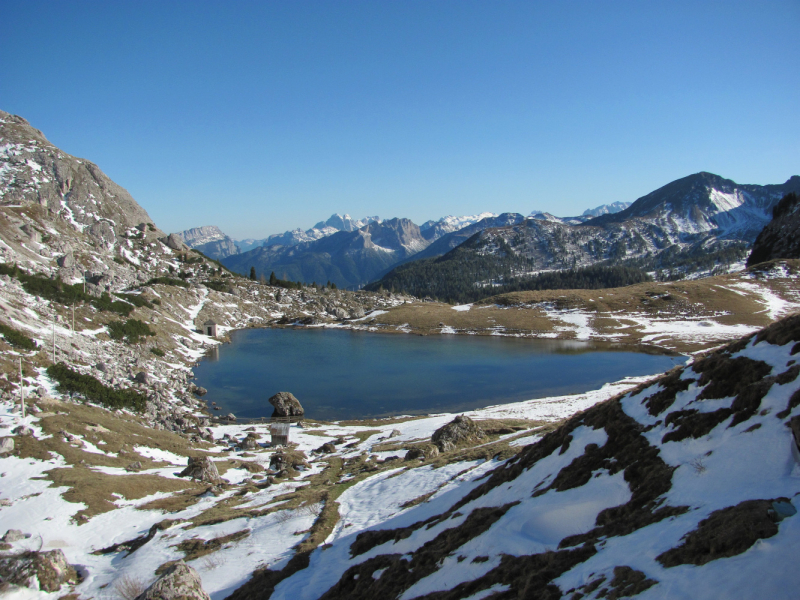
[0,550,78,592]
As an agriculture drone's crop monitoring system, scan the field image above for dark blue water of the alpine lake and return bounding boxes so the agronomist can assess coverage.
[194,329,685,420]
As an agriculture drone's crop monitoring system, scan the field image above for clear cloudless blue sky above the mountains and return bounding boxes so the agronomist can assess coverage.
[0,0,800,238]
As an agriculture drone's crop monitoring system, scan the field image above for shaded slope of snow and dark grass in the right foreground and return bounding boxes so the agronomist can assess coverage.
[232,316,800,600]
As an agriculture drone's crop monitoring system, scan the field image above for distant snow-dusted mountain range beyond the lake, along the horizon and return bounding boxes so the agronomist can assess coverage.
[209,172,800,292]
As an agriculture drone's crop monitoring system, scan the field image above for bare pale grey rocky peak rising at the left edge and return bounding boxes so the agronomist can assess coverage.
[0,111,156,247]
